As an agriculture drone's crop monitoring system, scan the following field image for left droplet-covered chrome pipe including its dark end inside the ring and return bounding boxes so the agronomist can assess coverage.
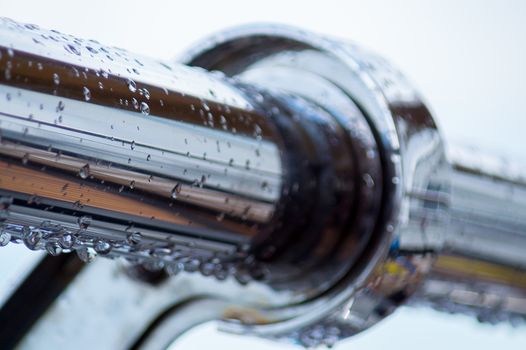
[0,20,372,299]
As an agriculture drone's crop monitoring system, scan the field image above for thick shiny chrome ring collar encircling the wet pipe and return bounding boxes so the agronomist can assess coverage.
[185,26,448,347]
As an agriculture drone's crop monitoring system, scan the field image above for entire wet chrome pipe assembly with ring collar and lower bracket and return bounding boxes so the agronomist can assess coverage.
[0,20,526,349]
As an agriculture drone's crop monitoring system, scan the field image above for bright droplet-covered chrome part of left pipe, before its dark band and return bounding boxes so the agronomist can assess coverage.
[0,20,282,290]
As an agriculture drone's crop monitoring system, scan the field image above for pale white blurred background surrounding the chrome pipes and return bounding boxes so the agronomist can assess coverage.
[0,0,526,350]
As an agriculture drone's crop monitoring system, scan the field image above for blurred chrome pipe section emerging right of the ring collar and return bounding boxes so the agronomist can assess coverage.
[411,147,526,325]
